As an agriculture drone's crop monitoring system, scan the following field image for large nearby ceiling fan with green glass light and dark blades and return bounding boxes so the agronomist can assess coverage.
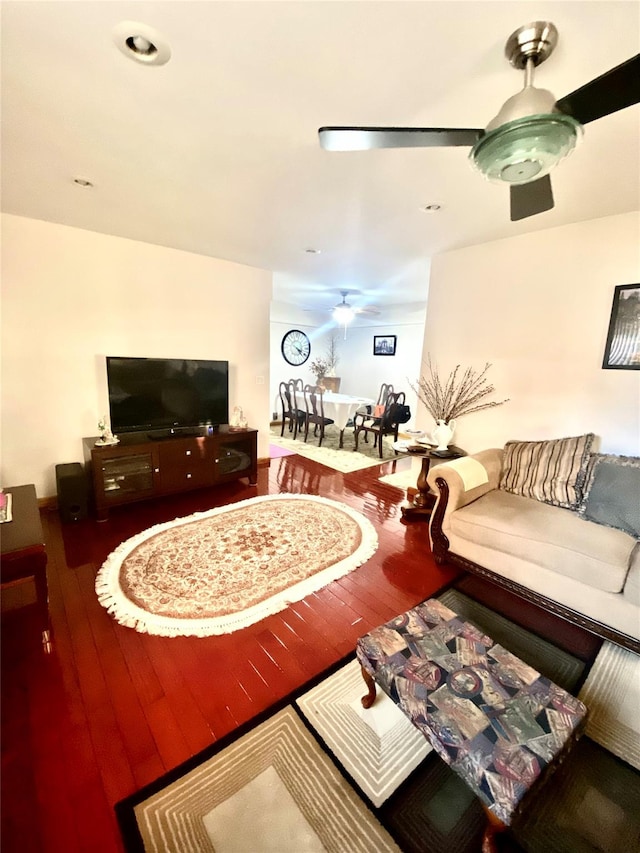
[318,21,640,221]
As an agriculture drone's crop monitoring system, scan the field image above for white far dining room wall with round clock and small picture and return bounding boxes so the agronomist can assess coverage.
[271,302,427,428]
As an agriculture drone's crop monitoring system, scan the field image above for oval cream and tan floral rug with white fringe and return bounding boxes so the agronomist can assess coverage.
[96,494,378,637]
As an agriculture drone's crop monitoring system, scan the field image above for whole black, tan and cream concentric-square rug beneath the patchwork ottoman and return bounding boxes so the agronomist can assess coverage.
[116,589,640,853]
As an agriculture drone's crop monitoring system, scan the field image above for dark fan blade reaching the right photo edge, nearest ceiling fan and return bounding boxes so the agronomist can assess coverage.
[556,53,640,124]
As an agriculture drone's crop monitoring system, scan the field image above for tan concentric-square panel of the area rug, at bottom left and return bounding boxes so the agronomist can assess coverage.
[120,707,400,853]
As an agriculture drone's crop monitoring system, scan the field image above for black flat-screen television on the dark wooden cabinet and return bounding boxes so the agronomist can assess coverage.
[107,356,229,434]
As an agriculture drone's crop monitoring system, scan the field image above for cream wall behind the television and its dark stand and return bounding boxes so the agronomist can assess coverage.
[0,215,272,497]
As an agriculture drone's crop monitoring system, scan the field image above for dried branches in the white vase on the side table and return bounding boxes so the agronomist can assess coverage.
[409,357,508,424]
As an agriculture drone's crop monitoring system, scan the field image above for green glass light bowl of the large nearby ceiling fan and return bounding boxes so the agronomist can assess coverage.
[469,113,582,184]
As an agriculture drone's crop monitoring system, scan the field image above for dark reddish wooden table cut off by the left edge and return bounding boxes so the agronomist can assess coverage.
[0,485,51,648]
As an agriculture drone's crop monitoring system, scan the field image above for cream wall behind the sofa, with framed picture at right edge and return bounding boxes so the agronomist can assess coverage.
[419,213,640,455]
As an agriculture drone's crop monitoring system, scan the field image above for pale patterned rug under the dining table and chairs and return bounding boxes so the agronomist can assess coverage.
[269,424,401,474]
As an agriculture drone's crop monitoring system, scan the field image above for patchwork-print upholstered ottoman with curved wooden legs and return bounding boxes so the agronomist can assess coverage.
[356,599,587,850]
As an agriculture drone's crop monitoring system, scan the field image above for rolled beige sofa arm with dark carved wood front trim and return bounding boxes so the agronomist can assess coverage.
[427,448,504,563]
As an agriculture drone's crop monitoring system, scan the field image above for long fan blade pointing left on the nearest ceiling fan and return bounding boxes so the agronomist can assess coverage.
[318,127,484,151]
